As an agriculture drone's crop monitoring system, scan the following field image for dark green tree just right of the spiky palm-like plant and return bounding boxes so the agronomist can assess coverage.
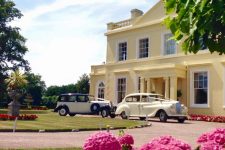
[25,72,46,105]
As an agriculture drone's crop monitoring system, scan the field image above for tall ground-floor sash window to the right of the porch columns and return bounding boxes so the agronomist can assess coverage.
[192,71,209,106]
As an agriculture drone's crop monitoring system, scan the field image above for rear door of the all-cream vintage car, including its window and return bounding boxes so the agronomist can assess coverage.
[125,95,140,116]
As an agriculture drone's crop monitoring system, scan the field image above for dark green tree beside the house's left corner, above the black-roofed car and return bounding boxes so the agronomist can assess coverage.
[76,74,90,93]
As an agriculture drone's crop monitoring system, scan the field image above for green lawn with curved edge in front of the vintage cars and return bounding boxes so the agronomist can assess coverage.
[0,110,145,131]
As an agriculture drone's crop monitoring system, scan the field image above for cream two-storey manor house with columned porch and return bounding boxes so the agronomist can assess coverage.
[90,1,225,116]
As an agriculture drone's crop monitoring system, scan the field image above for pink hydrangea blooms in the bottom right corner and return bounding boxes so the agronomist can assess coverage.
[197,128,225,150]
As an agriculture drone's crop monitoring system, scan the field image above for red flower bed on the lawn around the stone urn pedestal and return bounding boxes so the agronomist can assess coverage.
[0,114,38,120]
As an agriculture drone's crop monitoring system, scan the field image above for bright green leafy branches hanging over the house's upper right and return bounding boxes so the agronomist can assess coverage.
[164,0,225,55]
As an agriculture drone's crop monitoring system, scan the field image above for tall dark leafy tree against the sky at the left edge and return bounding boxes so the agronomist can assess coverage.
[0,0,29,103]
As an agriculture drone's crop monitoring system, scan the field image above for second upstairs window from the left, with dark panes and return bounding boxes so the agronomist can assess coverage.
[139,38,149,58]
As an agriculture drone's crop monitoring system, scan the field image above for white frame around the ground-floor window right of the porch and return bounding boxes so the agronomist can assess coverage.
[190,68,210,108]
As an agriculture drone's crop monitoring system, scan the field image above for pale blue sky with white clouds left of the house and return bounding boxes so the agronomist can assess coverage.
[13,0,158,86]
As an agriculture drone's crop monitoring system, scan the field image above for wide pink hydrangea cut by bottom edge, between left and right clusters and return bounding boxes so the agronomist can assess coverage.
[140,136,191,150]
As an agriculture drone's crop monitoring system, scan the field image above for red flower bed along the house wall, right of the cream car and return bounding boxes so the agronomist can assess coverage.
[189,114,225,123]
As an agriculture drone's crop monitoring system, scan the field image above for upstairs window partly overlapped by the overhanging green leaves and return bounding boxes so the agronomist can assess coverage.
[164,33,176,55]
